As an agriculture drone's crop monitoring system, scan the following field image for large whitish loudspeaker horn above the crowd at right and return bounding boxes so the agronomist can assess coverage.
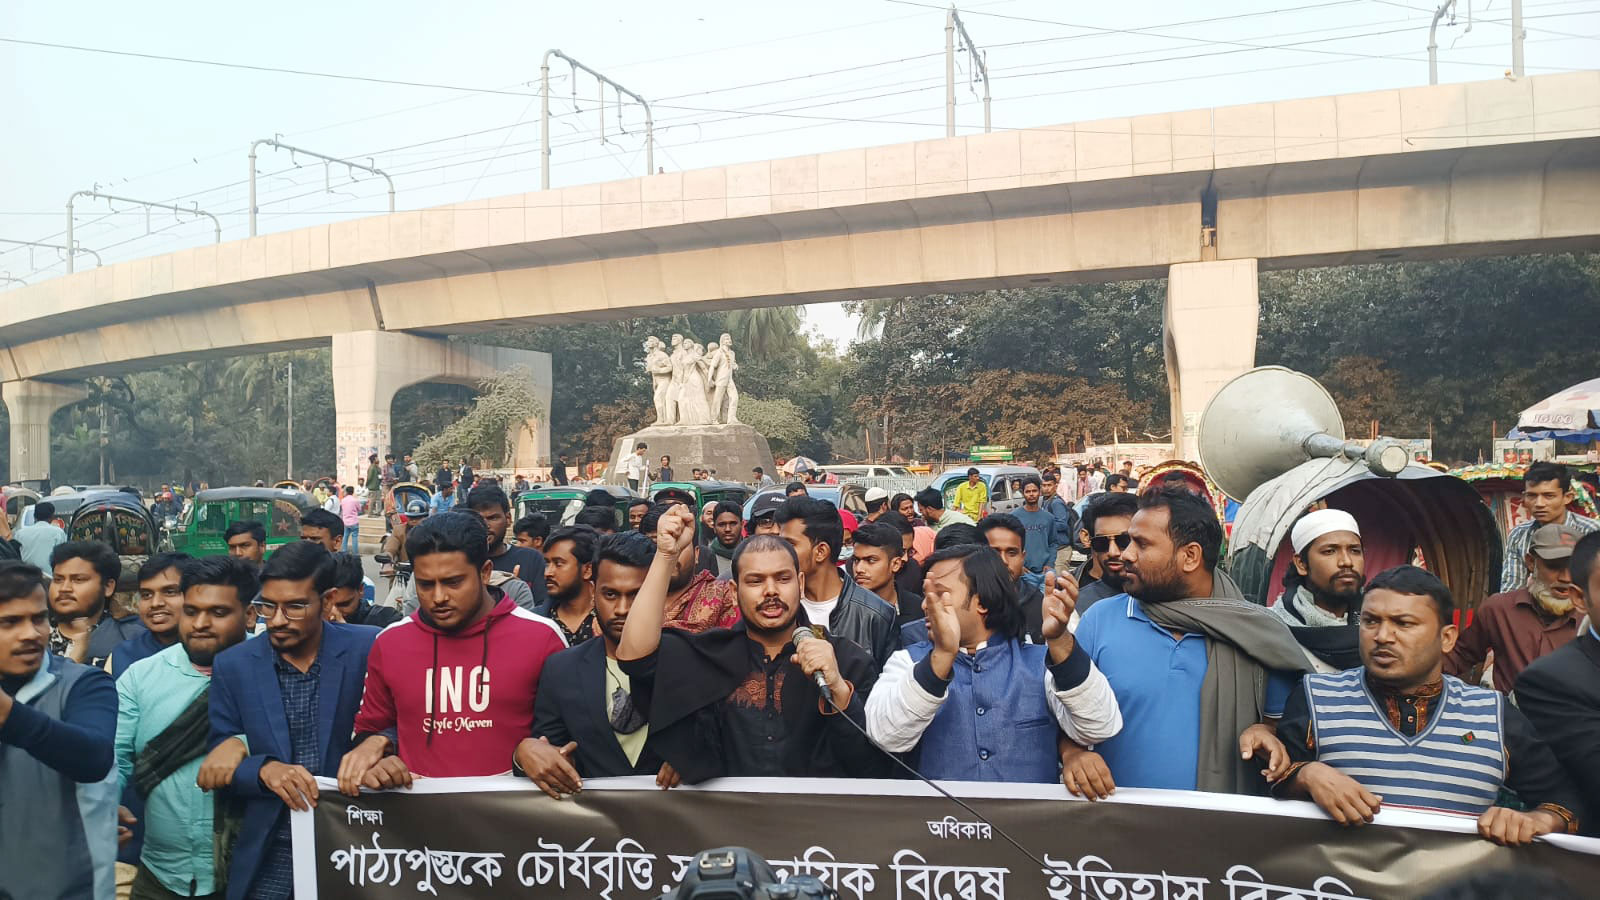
[1200,365,1410,501]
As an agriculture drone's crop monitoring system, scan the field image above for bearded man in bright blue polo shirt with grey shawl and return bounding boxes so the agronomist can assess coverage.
[1061,488,1306,799]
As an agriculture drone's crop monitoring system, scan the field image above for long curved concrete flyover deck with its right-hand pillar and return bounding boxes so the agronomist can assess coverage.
[0,72,1600,477]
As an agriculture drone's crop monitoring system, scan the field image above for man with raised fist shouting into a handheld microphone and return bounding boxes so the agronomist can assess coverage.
[616,506,890,785]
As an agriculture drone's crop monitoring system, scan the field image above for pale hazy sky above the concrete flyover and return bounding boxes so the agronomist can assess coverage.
[0,0,1600,344]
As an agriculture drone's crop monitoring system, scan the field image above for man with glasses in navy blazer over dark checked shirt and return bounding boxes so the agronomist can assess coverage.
[198,541,379,900]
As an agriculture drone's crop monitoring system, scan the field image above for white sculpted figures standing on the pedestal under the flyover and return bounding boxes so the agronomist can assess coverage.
[645,335,739,424]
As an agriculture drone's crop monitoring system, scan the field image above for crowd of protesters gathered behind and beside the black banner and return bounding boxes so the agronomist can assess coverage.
[0,461,1600,898]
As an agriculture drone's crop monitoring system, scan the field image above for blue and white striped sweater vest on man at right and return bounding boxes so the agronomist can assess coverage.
[1306,668,1506,815]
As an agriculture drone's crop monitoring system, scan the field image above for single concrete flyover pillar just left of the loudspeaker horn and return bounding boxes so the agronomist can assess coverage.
[1163,259,1261,461]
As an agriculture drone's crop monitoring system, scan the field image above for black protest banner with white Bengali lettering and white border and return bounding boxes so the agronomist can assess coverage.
[294,777,1600,900]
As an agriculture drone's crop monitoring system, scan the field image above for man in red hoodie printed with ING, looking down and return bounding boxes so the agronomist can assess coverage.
[339,511,566,796]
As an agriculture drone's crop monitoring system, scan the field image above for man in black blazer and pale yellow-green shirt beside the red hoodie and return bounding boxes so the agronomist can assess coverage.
[514,532,678,799]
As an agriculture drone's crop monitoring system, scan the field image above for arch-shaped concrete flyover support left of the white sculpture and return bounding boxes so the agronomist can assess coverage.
[333,331,550,484]
